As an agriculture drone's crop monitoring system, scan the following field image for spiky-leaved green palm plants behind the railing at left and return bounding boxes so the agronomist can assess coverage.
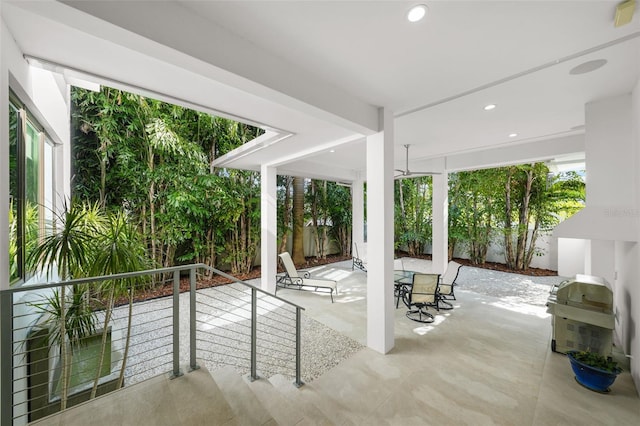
[29,200,150,410]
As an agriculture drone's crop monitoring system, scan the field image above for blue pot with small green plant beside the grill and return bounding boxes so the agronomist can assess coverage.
[567,350,622,393]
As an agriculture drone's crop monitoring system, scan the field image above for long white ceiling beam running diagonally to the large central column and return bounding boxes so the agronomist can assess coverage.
[53,1,378,134]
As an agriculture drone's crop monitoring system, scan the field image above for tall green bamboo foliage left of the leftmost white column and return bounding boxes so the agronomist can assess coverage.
[72,87,261,273]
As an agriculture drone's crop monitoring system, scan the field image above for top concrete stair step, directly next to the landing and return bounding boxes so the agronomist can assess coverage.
[211,367,277,426]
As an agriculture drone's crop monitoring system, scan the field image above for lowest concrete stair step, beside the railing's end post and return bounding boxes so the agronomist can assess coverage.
[269,374,338,425]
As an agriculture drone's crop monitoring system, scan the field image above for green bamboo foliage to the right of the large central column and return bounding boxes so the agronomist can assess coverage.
[395,163,585,270]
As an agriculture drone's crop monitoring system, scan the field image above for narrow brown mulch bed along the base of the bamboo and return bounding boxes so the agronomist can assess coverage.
[117,251,558,305]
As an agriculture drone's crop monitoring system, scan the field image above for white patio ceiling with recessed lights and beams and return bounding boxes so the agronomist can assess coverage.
[3,0,640,179]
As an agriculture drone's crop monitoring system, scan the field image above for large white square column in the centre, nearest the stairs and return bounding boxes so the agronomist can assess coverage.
[367,110,395,353]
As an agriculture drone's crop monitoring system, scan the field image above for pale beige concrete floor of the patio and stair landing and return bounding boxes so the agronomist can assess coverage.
[35,260,640,426]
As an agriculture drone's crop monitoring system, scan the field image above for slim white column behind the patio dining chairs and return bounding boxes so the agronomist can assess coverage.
[431,172,449,274]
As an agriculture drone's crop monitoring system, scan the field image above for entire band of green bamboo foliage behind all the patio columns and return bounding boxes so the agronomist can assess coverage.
[72,88,584,273]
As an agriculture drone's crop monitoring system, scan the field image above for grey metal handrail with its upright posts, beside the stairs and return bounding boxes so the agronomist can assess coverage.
[0,263,304,426]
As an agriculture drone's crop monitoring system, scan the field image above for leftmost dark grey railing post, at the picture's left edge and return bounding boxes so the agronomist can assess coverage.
[0,291,13,426]
